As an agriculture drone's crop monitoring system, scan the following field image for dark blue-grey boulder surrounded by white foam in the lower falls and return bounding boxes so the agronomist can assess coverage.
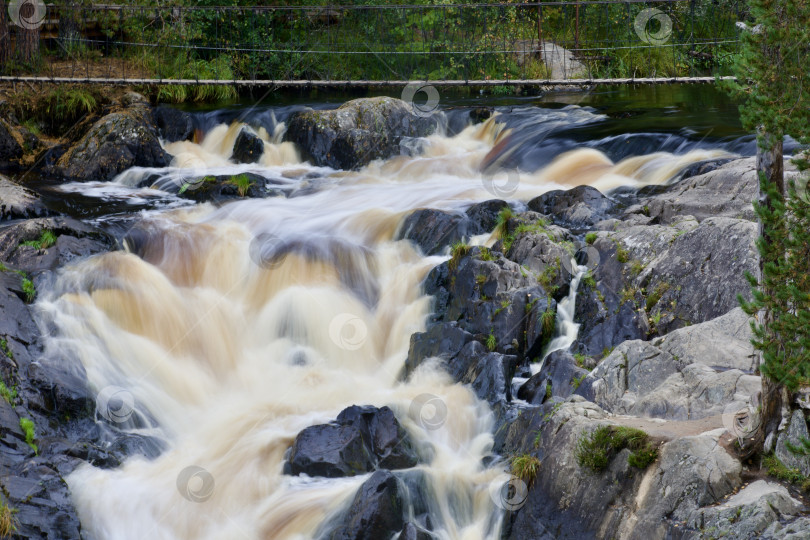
[285,405,417,478]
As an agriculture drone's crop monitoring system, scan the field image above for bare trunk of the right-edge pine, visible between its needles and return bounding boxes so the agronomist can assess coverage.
[740,129,790,458]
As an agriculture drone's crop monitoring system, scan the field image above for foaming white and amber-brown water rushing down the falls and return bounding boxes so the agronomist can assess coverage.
[40,90,744,540]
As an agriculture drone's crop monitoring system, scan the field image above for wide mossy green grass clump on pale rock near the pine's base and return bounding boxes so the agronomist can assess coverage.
[576,426,658,473]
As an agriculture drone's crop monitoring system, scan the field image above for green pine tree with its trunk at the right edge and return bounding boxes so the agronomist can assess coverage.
[731,0,810,455]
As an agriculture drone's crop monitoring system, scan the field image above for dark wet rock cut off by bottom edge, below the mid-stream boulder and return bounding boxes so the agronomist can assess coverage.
[329,470,405,540]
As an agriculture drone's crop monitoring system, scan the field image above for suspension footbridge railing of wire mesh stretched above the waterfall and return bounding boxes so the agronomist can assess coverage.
[0,0,746,84]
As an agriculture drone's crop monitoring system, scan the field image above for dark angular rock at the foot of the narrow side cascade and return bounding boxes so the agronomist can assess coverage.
[517,351,589,405]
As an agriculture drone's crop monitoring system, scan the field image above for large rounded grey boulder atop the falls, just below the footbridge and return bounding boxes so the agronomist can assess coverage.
[284,97,438,169]
